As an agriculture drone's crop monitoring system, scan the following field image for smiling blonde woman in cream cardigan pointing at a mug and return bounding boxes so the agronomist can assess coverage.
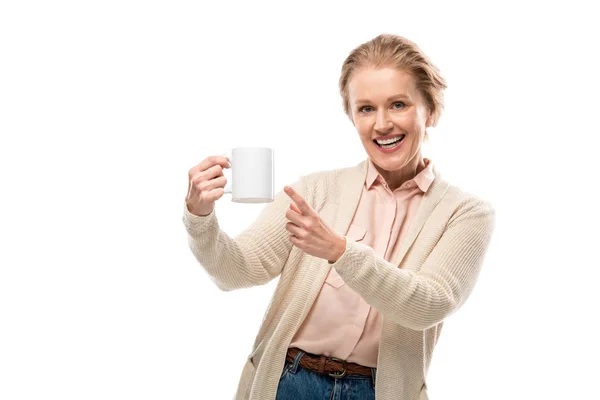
[183,35,495,400]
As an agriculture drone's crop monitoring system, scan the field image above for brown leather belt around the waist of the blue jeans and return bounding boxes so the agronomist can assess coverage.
[285,347,372,378]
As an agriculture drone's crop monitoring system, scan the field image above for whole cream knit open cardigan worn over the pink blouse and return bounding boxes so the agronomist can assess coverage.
[183,160,495,400]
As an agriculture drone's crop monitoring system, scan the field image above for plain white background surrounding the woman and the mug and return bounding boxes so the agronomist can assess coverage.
[0,0,600,400]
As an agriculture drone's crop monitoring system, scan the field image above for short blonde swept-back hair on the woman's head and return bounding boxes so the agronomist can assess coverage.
[339,34,447,140]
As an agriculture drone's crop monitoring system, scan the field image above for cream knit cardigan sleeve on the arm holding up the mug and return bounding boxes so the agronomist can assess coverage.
[182,176,306,291]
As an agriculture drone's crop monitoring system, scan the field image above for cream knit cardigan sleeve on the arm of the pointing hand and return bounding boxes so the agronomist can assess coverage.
[331,200,495,330]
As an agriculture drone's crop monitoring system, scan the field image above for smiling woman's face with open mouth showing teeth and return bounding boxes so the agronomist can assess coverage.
[348,68,430,175]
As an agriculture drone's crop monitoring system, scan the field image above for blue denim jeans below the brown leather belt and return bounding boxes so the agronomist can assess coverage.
[276,351,377,400]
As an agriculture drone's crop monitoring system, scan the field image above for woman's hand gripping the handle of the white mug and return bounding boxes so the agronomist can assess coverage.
[185,156,231,217]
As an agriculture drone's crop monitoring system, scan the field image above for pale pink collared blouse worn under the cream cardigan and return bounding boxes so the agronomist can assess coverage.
[290,158,435,367]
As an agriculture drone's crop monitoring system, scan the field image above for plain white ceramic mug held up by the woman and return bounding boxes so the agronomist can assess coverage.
[223,147,275,203]
